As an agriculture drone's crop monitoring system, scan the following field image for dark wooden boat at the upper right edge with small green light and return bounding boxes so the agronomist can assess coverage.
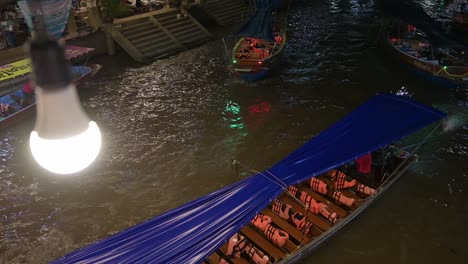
[386,25,468,87]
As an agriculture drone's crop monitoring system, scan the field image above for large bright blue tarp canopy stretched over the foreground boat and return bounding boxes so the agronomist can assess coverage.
[53,95,446,263]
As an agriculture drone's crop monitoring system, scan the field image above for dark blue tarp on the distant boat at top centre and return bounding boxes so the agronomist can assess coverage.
[236,0,284,42]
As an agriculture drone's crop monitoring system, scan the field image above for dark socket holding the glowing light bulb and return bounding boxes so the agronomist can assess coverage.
[29,37,72,91]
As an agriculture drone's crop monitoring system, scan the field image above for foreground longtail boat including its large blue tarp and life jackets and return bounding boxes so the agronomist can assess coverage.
[52,95,446,264]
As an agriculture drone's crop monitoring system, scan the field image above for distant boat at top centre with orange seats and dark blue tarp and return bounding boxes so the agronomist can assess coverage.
[231,0,286,82]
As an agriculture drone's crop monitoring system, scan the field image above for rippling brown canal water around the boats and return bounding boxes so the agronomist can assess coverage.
[0,0,468,263]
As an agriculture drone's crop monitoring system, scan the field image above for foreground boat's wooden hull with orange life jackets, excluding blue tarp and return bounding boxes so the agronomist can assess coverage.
[203,146,418,264]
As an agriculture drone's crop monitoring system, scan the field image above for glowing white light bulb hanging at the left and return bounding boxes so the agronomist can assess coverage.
[29,84,101,174]
